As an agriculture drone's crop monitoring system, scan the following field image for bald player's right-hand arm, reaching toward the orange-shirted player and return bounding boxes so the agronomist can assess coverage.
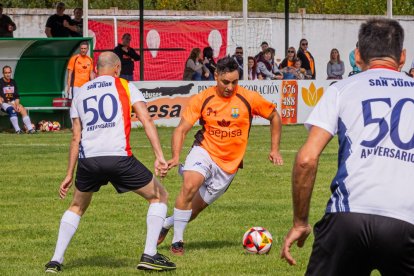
[132,102,168,177]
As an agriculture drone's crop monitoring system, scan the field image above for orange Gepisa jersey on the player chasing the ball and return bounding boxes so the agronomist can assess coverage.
[182,86,276,173]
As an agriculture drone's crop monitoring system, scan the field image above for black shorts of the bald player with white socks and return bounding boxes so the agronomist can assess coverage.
[75,156,153,193]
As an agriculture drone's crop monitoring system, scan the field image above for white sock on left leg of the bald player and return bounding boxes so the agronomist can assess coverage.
[52,210,81,264]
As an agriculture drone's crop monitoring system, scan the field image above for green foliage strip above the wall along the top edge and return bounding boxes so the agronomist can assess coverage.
[2,0,414,15]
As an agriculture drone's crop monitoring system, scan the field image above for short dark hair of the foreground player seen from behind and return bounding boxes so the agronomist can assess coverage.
[358,18,404,64]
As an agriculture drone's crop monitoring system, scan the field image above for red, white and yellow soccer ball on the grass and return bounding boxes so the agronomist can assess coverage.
[243,227,273,254]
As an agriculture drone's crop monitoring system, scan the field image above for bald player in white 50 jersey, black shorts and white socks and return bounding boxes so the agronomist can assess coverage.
[45,52,176,273]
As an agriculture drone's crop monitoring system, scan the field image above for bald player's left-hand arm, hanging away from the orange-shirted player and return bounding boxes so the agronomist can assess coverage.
[59,118,82,199]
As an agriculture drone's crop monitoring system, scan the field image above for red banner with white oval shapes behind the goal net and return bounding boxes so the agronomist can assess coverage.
[88,19,227,80]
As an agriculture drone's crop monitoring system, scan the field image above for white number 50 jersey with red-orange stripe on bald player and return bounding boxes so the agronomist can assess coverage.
[70,76,146,158]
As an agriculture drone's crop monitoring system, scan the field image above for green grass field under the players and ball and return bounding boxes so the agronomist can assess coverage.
[0,126,348,275]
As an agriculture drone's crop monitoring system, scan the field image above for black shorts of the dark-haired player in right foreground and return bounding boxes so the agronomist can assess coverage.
[306,213,414,276]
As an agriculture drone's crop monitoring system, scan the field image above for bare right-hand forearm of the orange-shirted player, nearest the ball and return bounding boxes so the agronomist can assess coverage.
[268,110,283,166]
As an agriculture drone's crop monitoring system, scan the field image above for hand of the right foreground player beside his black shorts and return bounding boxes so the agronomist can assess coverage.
[280,224,312,265]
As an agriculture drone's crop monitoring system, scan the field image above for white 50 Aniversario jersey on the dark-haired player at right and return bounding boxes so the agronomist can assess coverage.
[305,68,414,224]
